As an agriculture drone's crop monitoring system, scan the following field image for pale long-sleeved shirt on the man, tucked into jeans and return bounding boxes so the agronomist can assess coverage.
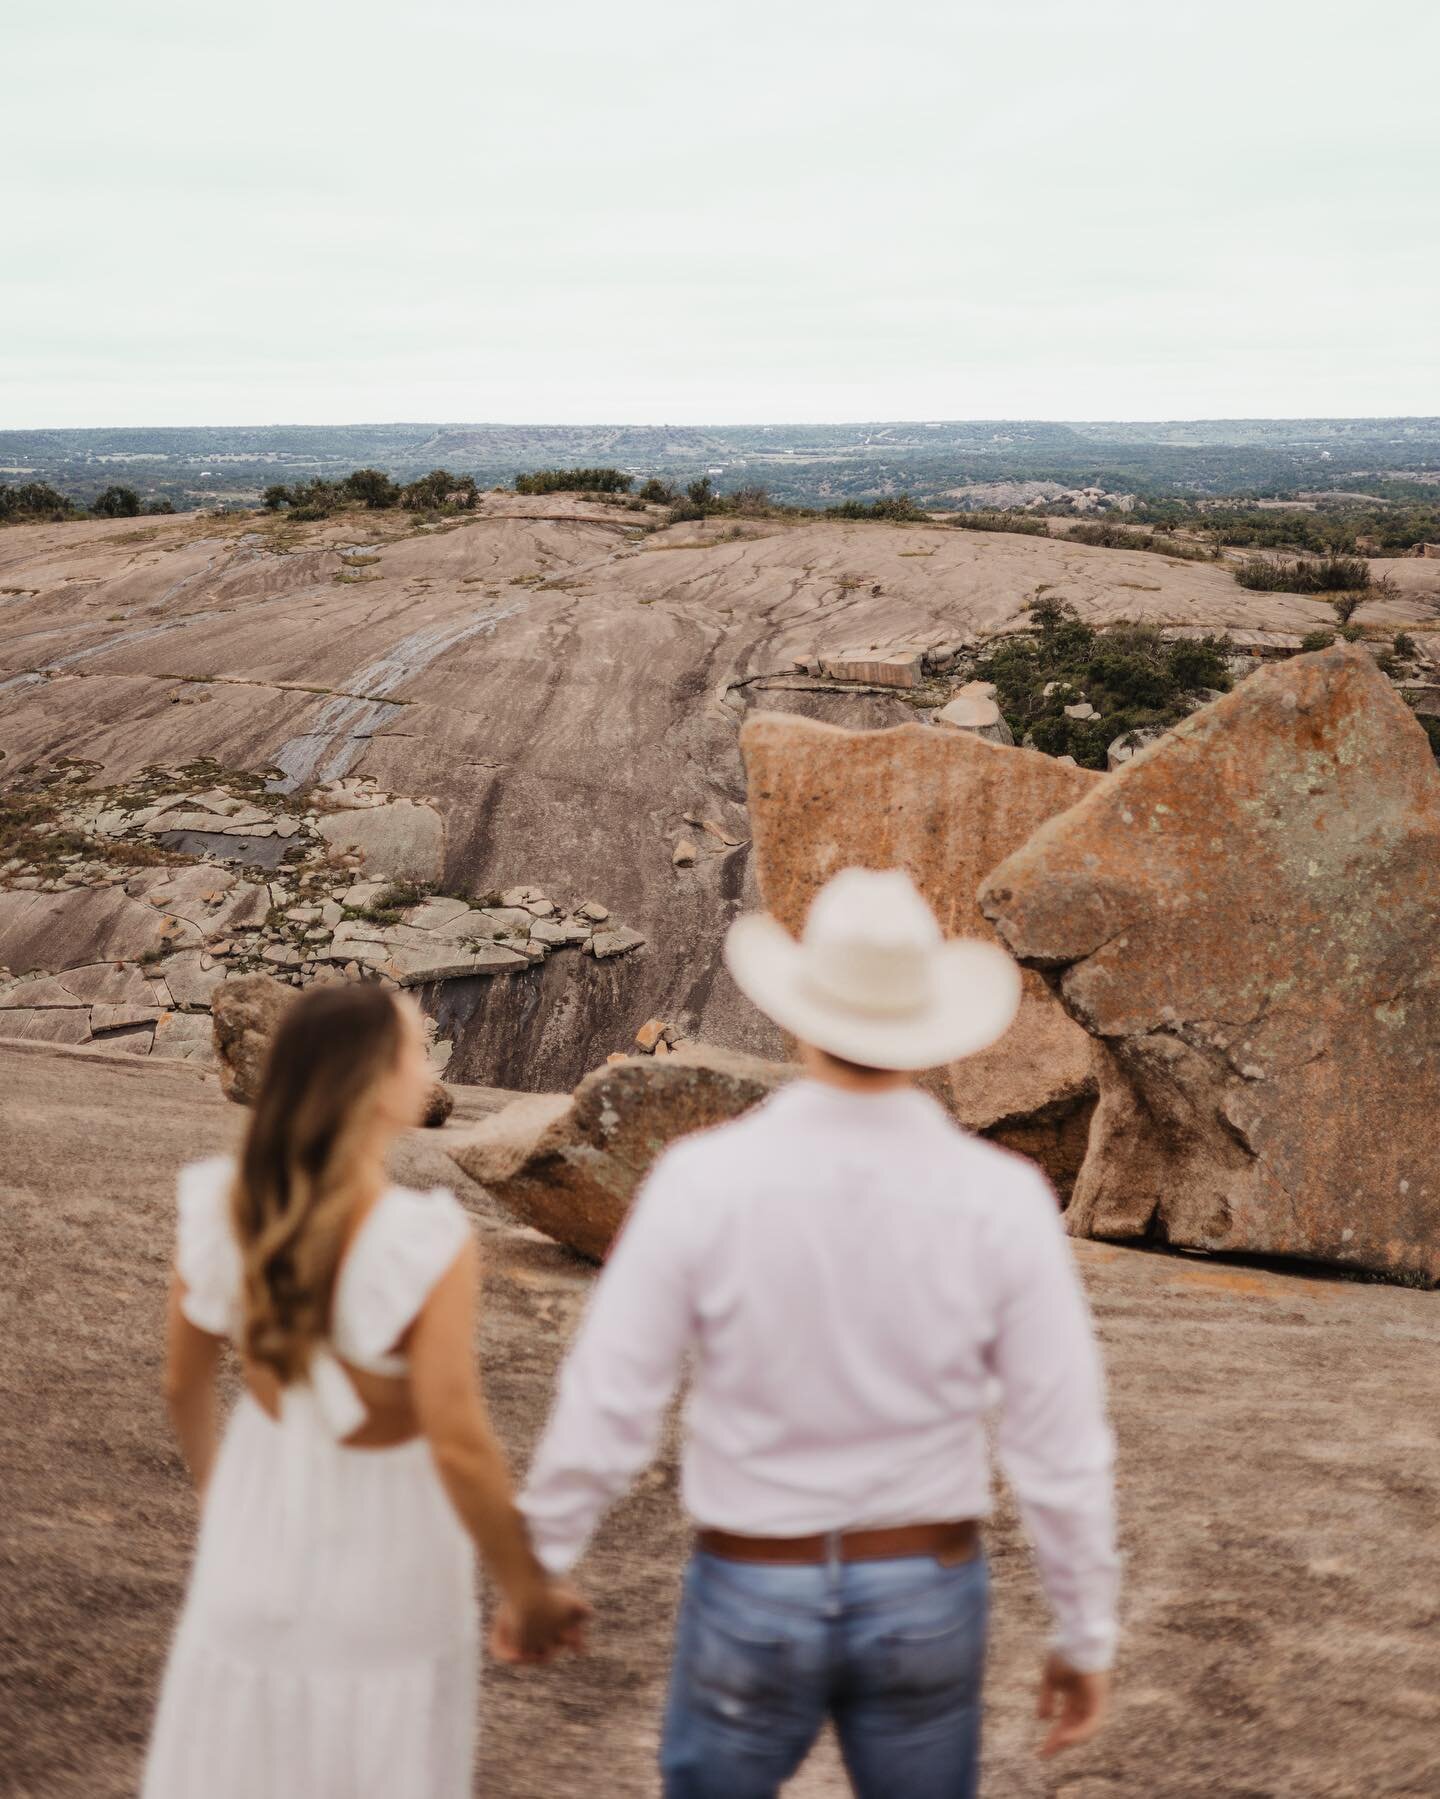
[520,1081,1118,1669]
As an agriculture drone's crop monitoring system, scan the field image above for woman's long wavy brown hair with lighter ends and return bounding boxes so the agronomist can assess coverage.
[230,980,403,1383]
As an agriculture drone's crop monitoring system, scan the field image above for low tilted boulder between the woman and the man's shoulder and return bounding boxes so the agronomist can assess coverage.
[446,1043,797,1261]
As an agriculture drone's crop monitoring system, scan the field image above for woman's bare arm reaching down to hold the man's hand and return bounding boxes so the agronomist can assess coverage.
[407,1240,589,1657]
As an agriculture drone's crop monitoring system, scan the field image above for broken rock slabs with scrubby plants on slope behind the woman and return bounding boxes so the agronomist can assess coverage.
[0,763,644,1079]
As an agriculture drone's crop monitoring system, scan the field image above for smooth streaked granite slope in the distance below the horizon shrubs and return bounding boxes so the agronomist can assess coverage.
[0,495,1440,1090]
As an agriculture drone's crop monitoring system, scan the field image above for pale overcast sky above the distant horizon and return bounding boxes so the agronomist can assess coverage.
[0,0,1440,426]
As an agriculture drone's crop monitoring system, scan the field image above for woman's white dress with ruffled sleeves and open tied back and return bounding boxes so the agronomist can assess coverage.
[142,1159,479,1799]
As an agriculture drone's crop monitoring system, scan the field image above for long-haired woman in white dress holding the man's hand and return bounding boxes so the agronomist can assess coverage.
[144,982,587,1799]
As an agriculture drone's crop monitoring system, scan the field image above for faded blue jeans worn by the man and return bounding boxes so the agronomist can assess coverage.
[661,1553,990,1799]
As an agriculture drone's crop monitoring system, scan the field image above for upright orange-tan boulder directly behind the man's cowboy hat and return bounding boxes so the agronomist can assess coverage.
[740,712,1105,1196]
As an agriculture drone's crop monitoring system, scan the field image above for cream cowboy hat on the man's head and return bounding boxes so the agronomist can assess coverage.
[725,869,1021,1069]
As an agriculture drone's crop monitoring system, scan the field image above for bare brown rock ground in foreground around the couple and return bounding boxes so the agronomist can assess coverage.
[0,1043,1440,1799]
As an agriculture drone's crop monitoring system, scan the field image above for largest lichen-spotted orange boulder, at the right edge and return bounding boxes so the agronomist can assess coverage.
[981,646,1440,1281]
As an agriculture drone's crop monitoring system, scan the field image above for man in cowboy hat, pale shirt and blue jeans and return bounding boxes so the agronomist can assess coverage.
[497,869,1118,1799]
